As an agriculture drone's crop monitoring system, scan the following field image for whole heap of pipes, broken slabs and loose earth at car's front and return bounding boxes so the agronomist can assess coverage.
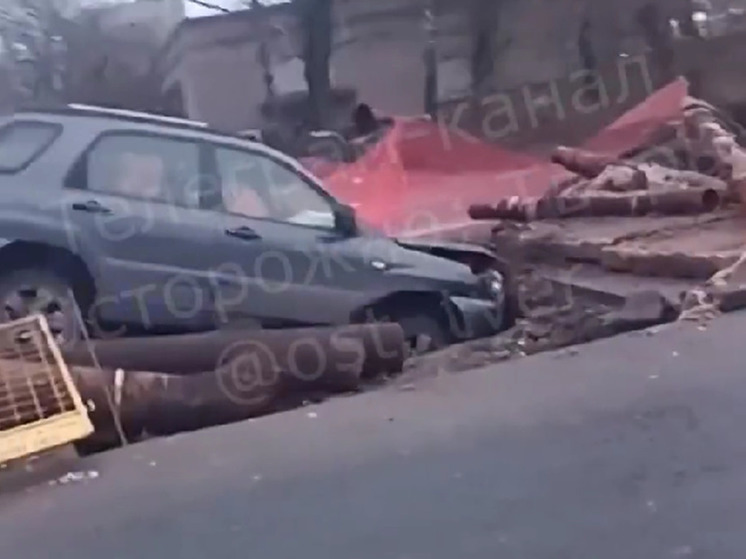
[372,83,746,385]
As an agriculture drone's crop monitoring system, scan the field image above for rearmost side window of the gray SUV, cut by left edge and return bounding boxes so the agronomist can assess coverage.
[0,122,60,173]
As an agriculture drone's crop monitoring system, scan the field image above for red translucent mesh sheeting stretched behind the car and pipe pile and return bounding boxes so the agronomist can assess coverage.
[310,76,687,234]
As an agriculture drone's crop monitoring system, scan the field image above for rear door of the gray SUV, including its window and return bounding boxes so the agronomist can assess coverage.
[62,130,215,328]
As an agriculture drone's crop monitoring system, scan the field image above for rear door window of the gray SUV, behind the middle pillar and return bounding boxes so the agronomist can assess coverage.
[85,133,200,208]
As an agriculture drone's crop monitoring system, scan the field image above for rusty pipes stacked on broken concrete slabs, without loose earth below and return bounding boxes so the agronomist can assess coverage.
[470,85,746,326]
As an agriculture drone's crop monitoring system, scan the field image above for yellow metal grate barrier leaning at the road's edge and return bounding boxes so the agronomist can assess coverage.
[0,316,93,462]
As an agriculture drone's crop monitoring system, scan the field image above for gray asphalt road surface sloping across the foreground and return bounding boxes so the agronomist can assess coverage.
[0,315,746,559]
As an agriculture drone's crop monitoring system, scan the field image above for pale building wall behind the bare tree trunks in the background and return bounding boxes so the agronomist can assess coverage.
[160,0,684,135]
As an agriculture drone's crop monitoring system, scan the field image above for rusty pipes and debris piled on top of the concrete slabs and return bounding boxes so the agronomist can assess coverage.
[469,93,746,222]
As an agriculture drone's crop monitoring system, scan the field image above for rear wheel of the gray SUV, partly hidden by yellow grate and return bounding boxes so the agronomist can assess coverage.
[0,268,84,346]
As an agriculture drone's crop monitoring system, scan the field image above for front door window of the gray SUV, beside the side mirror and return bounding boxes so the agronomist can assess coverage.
[216,148,334,228]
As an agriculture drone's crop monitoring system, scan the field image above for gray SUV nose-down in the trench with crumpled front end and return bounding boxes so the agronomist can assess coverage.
[0,106,512,346]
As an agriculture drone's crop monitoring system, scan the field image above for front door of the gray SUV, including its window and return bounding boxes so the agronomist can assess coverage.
[205,147,370,326]
